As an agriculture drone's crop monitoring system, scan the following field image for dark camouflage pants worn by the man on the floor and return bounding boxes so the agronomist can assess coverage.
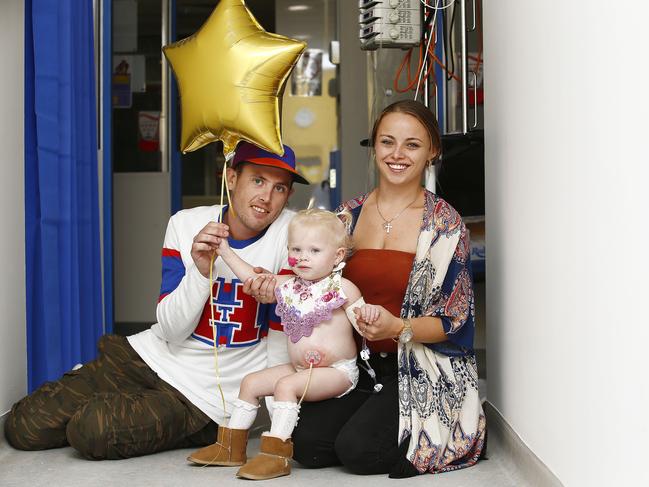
[5,335,217,460]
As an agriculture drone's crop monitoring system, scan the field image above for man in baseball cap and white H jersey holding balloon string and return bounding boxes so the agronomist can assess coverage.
[5,143,307,459]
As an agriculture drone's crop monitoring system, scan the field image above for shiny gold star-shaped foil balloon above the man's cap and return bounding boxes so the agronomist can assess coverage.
[162,0,306,155]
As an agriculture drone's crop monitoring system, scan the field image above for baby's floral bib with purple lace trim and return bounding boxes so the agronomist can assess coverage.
[275,273,347,343]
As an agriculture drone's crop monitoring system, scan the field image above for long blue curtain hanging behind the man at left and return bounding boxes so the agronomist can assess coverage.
[25,0,103,391]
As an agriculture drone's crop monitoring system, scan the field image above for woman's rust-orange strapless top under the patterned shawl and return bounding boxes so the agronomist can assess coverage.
[343,249,415,353]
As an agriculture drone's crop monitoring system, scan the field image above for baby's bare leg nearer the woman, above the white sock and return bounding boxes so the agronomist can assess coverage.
[274,367,351,402]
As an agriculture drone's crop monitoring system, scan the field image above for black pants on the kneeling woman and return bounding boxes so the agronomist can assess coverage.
[293,354,401,474]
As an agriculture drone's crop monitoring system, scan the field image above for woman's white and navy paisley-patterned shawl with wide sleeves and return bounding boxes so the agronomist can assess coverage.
[343,191,485,473]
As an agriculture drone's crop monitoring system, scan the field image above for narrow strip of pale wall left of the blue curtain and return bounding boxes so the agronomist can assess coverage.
[0,0,27,416]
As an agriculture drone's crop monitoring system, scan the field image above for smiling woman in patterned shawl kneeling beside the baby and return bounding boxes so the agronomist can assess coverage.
[293,100,486,477]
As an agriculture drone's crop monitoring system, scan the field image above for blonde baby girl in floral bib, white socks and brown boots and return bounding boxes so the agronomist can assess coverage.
[189,209,379,480]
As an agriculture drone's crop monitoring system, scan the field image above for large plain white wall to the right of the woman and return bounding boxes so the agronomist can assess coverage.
[484,0,649,487]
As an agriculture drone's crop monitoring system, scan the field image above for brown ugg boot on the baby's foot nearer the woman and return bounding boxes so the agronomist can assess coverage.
[237,435,293,480]
